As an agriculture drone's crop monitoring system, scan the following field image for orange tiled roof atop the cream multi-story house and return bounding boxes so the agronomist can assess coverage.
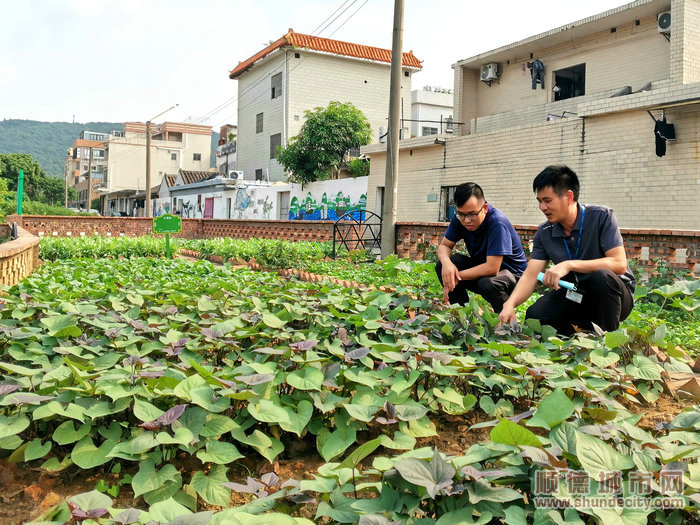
[229,28,423,78]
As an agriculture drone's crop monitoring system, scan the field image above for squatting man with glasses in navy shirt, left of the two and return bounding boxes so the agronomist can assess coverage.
[435,182,527,312]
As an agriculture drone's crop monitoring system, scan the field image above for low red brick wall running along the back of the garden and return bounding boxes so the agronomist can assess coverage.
[7,215,700,274]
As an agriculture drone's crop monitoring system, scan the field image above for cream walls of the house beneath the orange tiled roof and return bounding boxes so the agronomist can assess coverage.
[236,49,412,182]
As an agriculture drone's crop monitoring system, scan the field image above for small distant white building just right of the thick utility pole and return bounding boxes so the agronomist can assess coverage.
[411,86,455,137]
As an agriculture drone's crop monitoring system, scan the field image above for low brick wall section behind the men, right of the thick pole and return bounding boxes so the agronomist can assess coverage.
[396,222,700,275]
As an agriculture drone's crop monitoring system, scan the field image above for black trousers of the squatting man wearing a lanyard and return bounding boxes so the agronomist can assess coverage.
[525,270,634,335]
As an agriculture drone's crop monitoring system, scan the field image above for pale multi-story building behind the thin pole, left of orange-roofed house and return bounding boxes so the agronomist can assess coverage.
[97,122,211,216]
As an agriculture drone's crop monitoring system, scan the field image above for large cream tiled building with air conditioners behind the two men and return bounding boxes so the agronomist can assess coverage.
[362,0,700,231]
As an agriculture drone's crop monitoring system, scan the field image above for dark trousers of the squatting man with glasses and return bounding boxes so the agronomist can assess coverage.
[435,253,518,313]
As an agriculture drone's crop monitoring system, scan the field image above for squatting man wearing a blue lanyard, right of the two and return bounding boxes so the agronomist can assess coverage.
[498,166,635,335]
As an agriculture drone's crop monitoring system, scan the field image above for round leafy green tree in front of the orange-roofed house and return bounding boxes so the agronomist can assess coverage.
[277,102,372,184]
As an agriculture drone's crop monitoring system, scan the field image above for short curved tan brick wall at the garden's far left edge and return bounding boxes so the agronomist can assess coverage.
[0,223,39,286]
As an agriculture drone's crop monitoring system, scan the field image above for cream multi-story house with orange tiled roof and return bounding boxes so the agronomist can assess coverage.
[229,29,422,182]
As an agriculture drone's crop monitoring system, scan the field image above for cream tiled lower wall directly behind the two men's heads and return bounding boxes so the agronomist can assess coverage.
[367,103,700,230]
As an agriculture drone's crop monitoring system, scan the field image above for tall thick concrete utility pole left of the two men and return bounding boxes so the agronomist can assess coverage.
[382,0,403,259]
